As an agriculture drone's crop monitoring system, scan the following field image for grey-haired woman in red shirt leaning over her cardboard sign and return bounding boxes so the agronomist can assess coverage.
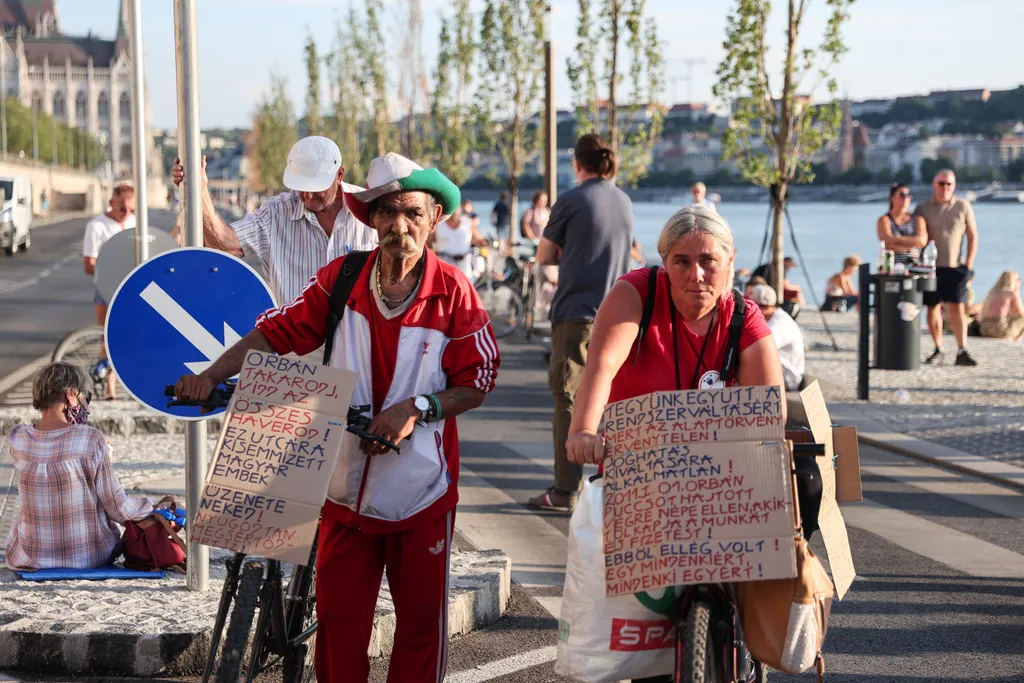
[566,206,785,464]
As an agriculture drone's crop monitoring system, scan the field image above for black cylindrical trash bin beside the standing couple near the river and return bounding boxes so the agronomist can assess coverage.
[874,274,933,370]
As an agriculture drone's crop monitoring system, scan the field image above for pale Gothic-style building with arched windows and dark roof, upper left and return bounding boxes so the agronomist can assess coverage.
[0,0,163,184]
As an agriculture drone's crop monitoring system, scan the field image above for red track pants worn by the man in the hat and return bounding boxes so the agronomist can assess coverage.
[316,510,455,683]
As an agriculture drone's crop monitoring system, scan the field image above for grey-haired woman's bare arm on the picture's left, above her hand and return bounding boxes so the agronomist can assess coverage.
[569,280,638,435]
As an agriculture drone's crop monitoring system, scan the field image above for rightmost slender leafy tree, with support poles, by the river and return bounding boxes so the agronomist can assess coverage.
[714,0,854,299]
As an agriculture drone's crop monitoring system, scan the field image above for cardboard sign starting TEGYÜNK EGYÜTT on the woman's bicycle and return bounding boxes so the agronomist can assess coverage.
[604,387,797,597]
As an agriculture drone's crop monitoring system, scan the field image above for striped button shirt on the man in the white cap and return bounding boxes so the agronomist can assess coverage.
[231,184,377,306]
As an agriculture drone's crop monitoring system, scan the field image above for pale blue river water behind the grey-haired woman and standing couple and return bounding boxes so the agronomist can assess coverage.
[633,202,1024,302]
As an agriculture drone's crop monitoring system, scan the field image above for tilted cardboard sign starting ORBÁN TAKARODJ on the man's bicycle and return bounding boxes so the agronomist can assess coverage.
[189,351,356,563]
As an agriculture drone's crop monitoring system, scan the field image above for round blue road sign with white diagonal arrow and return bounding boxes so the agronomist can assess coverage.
[106,247,274,420]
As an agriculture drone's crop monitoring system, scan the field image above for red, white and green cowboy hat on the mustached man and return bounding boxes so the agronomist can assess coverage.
[345,152,462,227]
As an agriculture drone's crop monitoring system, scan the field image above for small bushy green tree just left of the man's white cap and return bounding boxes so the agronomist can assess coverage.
[253,74,298,190]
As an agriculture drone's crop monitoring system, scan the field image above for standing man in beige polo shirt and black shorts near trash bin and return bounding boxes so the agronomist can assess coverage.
[913,169,978,368]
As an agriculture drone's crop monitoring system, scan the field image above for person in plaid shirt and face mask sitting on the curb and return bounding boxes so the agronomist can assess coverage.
[6,362,163,570]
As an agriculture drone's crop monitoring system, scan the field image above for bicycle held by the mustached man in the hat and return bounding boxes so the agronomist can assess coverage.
[164,382,400,683]
